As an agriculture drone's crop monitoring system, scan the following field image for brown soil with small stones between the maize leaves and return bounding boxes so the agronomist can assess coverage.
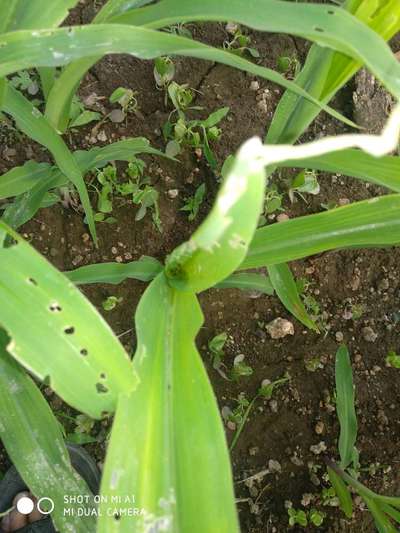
[1,2,400,533]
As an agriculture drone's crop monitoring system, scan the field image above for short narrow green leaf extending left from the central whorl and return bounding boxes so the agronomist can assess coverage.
[64,256,163,285]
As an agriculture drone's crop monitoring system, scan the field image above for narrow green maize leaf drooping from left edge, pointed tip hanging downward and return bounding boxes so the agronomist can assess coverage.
[4,86,97,243]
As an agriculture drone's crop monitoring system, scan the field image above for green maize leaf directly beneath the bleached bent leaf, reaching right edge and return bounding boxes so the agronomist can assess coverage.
[278,149,400,192]
